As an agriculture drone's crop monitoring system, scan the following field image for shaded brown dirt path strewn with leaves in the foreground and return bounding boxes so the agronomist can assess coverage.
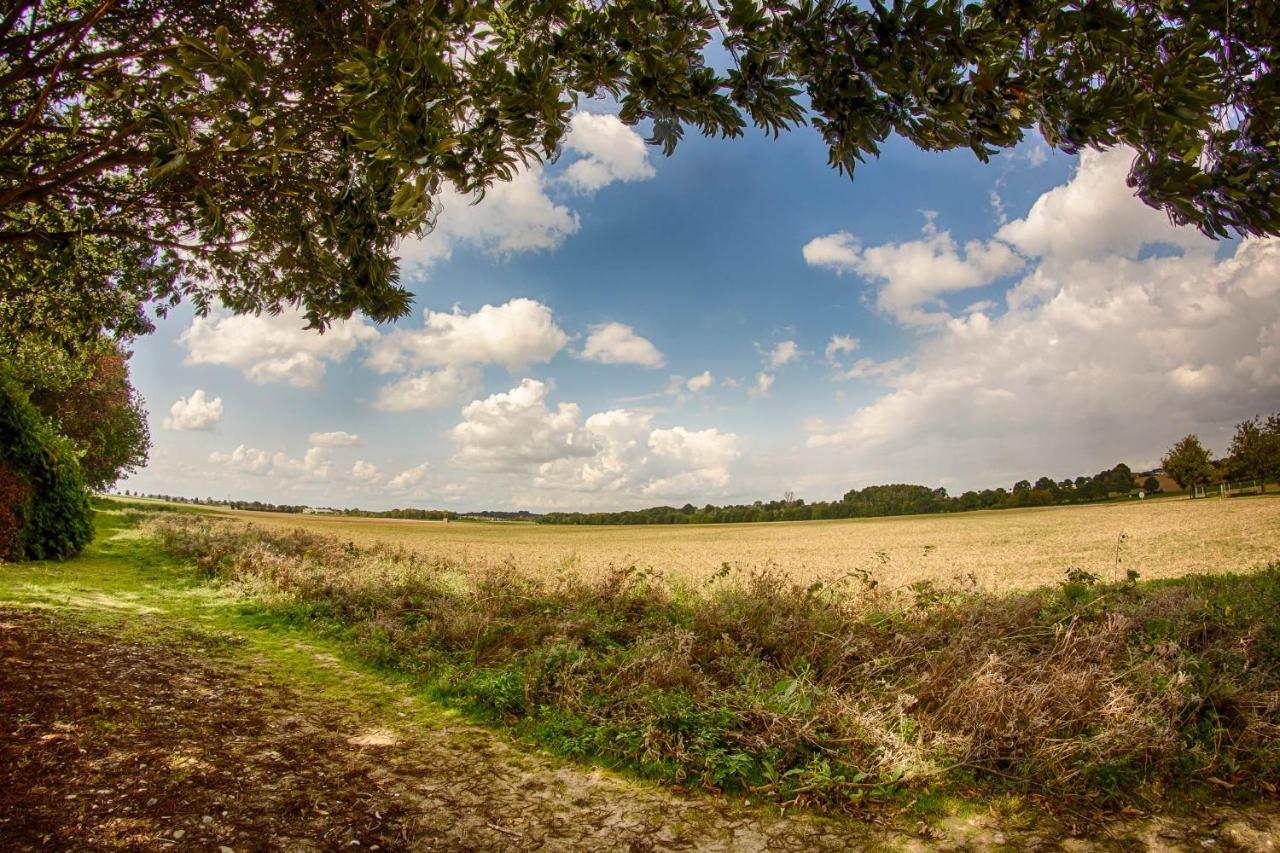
[0,608,1280,853]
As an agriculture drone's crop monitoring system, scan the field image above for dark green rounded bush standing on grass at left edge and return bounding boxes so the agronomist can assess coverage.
[0,369,93,560]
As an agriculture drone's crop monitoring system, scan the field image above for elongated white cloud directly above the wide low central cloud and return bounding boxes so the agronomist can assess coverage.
[366,297,568,373]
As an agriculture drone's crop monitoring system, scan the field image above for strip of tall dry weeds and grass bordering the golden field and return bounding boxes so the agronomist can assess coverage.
[151,516,1280,808]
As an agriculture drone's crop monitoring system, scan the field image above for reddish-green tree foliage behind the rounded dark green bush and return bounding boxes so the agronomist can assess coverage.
[14,338,151,489]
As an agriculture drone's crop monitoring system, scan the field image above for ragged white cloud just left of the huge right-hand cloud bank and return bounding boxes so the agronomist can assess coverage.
[803,214,1024,325]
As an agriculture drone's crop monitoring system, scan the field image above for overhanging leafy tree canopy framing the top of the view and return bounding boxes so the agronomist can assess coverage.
[0,0,1280,339]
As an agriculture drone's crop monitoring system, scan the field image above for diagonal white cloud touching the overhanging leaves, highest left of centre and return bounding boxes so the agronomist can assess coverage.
[399,113,654,270]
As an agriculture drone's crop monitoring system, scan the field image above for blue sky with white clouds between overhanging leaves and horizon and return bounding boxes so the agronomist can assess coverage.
[119,102,1280,511]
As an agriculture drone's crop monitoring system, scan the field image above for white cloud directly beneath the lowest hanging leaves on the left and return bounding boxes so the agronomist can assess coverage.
[178,310,378,388]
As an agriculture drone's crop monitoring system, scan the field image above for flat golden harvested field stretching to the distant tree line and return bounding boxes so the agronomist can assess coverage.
[212,496,1280,589]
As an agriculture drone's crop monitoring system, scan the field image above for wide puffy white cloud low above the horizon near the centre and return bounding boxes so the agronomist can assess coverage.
[449,379,741,497]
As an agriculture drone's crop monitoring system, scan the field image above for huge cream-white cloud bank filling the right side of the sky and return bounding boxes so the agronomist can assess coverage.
[808,150,1280,482]
